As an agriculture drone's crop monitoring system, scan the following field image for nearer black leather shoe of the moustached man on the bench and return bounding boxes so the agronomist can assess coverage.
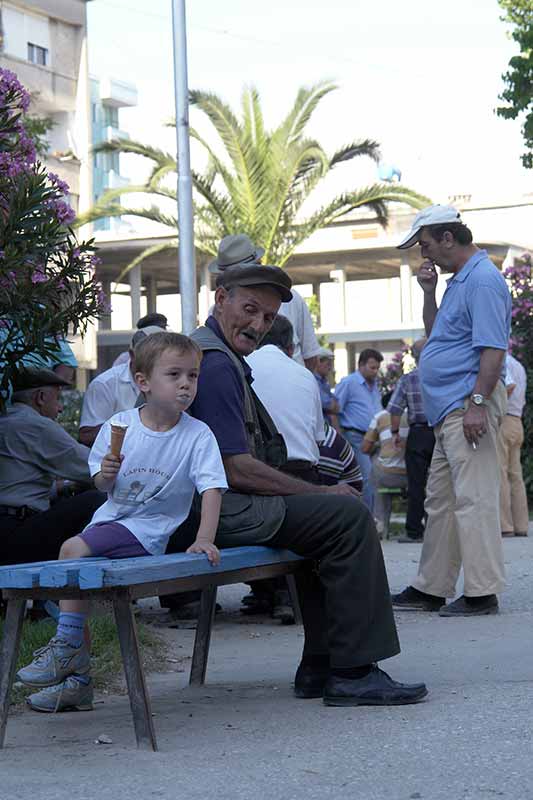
[324,665,428,706]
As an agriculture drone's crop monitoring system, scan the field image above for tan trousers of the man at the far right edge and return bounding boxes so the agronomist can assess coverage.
[498,414,529,533]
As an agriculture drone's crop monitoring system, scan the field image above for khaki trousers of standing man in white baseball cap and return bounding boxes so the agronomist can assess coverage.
[412,381,507,597]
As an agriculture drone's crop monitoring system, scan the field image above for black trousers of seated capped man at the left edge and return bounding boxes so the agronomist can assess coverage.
[0,490,106,565]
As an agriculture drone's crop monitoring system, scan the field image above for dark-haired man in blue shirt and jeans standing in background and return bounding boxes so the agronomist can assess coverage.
[335,348,383,511]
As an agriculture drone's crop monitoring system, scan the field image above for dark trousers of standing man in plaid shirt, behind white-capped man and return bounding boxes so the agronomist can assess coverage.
[405,425,435,539]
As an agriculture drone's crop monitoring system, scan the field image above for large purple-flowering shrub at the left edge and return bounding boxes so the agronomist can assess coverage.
[0,69,107,411]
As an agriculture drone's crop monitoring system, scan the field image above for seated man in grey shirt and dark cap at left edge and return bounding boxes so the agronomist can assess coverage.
[0,367,105,564]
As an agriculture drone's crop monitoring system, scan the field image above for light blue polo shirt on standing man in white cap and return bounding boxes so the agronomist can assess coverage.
[419,250,511,425]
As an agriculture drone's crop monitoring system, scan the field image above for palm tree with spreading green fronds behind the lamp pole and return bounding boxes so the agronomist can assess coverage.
[77,83,429,277]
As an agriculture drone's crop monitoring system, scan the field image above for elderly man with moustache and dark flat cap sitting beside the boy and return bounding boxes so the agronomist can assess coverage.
[167,263,427,706]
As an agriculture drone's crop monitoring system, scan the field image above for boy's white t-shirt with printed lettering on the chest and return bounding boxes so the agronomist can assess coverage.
[87,408,228,555]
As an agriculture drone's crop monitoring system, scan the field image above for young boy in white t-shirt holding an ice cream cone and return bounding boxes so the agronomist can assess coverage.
[17,333,227,711]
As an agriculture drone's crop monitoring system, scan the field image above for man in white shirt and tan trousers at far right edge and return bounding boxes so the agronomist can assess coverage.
[498,353,529,536]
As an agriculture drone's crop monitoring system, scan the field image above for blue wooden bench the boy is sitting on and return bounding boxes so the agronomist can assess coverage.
[0,547,309,750]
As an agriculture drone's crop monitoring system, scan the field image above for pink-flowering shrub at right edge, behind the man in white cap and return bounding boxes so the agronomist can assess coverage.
[504,253,533,500]
